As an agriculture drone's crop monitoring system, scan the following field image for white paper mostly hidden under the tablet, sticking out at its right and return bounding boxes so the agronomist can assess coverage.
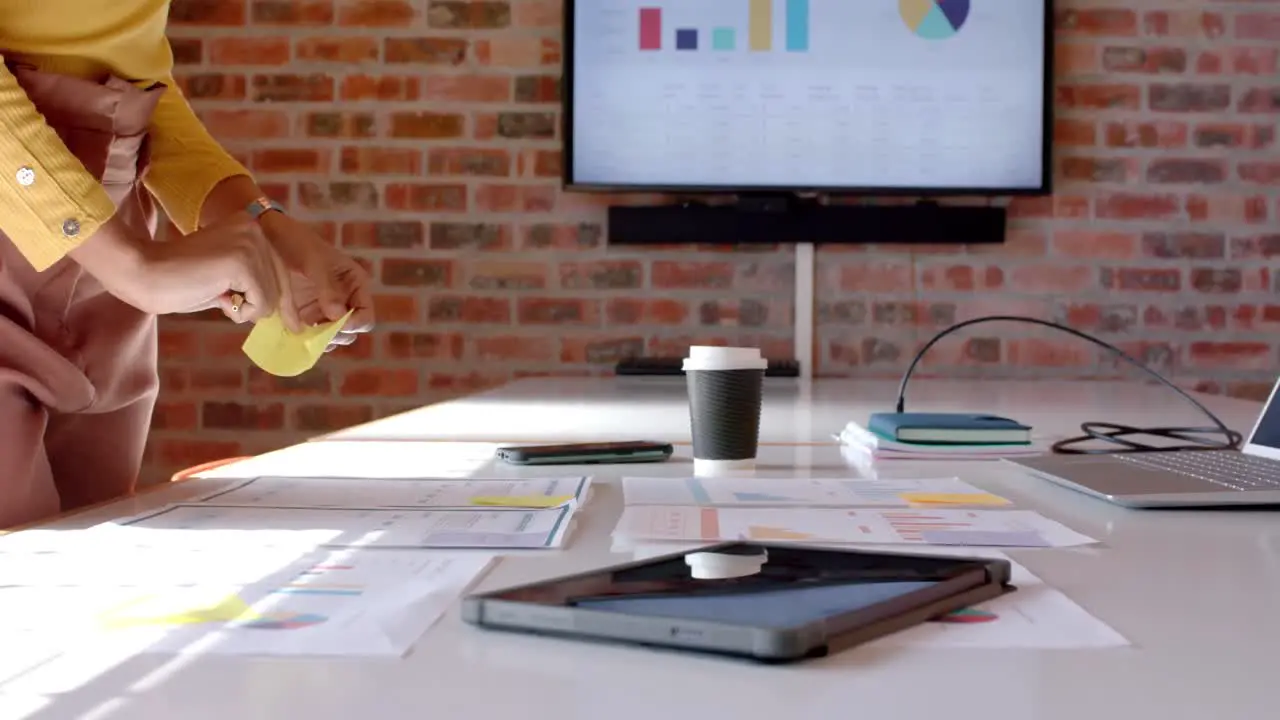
[616,543,1130,650]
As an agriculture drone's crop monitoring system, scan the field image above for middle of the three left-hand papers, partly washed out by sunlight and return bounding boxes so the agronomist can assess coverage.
[61,505,573,550]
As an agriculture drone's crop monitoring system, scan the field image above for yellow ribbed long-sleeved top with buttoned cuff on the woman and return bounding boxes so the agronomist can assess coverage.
[0,0,248,270]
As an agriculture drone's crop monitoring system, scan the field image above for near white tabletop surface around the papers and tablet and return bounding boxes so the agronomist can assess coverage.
[0,425,1280,720]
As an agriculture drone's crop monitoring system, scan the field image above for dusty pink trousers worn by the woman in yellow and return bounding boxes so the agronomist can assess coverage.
[0,67,164,528]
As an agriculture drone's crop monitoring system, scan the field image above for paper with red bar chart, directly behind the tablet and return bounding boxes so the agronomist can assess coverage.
[613,505,1096,547]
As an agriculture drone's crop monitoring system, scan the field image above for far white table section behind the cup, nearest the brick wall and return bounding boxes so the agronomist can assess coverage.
[319,377,1257,443]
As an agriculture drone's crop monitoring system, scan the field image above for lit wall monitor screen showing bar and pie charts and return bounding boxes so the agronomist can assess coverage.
[566,0,1051,193]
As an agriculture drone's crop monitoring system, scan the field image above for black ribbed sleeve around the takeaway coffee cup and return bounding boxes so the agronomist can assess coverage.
[685,370,764,460]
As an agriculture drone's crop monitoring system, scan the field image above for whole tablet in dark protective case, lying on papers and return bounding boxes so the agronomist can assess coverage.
[462,542,1014,662]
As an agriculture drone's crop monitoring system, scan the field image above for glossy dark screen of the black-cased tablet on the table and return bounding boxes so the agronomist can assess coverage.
[486,543,977,628]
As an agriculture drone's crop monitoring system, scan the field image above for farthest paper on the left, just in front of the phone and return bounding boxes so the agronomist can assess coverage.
[196,478,590,509]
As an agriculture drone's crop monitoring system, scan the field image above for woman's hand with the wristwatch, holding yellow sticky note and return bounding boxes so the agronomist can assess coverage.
[259,213,374,352]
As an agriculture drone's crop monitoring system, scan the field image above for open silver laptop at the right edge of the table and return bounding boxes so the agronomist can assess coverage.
[1005,380,1280,507]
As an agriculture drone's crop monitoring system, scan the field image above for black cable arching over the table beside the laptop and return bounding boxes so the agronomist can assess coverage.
[897,315,1244,455]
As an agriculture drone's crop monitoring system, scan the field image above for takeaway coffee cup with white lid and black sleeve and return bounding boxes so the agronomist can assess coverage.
[684,346,769,477]
